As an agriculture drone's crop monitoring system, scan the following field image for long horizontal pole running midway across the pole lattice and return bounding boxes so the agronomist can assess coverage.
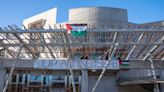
[0,42,163,48]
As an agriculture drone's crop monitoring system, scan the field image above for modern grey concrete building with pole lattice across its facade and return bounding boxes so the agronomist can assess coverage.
[0,7,164,92]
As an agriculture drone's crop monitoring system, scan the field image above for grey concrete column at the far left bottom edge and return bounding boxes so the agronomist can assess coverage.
[0,68,6,92]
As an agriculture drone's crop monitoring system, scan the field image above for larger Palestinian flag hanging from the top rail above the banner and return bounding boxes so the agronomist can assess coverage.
[66,24,87,36]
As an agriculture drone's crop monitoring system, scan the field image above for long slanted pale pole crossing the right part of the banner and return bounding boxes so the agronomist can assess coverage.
[92,43,118,92]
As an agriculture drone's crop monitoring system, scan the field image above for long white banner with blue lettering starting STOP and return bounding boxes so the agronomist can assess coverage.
[34,59,119,69]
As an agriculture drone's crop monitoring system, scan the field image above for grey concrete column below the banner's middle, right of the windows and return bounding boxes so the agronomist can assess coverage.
[81,69,88,92]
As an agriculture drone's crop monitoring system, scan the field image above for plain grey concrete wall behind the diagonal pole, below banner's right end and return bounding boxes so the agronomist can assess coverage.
[88,76,150,92]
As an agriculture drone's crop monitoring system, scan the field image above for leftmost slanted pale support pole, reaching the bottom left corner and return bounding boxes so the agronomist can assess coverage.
[3,45,22,92]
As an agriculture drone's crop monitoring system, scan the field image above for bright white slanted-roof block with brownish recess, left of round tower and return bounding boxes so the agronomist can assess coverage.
[23,8,57,29]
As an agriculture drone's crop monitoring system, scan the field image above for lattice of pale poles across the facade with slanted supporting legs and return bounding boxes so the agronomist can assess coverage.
[0,26,164,92]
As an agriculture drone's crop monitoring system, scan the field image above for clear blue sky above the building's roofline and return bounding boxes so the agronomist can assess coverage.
[0,0,164,27]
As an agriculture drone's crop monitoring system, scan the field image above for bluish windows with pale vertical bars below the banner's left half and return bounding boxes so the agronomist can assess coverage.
[7,71,81,92]
